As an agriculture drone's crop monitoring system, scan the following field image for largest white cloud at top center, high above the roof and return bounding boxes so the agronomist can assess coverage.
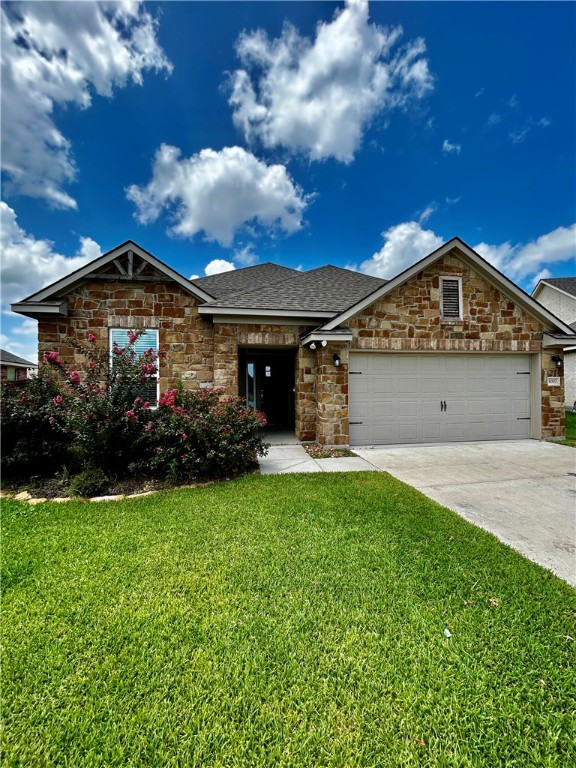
[229,0,433,163]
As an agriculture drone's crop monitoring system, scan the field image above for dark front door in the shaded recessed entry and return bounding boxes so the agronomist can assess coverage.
[239,349,296,428]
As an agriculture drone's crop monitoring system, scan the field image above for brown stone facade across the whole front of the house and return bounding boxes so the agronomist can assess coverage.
[39,253,564,446]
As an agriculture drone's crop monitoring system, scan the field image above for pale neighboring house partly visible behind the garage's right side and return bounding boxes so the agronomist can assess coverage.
[532,277,576,408]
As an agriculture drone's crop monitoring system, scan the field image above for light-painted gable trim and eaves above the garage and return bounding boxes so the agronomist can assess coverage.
[323,237,573,336]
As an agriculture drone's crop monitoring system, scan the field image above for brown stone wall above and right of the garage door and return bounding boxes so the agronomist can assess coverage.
[348,254,565,437]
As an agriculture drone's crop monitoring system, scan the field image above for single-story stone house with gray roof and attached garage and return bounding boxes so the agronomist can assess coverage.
[12,238,576,446]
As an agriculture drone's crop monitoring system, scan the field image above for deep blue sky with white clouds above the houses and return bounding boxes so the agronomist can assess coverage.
[0,0,576,359]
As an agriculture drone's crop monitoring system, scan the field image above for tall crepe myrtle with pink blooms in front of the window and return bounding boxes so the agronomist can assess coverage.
[2,331,158,476]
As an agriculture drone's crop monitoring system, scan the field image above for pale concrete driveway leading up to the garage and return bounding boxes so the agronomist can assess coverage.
[354,440,576,587]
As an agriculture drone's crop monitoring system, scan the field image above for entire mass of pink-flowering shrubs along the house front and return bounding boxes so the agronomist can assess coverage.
[2,331,267,480]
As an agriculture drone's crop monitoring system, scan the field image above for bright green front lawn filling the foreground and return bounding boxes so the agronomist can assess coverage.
[2,473,576,768]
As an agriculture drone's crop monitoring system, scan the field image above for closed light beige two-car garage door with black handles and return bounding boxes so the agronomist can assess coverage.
[349,352,530,445]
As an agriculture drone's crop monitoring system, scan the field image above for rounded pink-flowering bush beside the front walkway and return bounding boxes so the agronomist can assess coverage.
[141,387,268,480]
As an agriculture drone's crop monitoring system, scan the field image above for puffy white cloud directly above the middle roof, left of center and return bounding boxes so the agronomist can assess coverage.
[127,144,307,247]
